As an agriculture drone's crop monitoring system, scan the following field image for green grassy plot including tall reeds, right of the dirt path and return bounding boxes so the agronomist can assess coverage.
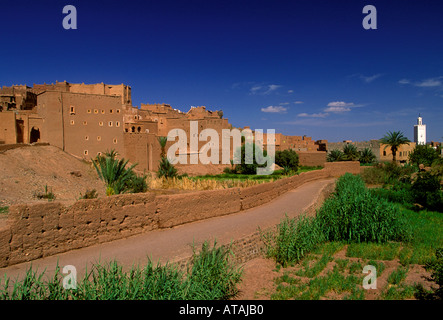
[263,175,443,300]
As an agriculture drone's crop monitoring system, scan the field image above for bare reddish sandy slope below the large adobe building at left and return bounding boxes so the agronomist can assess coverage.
[0,146,105,207]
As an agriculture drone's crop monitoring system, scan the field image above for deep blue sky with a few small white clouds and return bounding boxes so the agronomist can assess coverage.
[0,0,443,142]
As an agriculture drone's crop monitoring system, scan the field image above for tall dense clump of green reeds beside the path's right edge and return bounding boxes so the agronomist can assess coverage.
[262,173,412,265]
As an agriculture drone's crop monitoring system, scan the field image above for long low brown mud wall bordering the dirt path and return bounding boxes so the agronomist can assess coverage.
[0,162,360,267]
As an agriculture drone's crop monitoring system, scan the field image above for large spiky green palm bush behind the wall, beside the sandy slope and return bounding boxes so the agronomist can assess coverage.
[92,149,137,196]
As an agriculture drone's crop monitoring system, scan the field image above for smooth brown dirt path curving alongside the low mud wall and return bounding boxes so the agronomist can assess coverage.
[0,179,334,279]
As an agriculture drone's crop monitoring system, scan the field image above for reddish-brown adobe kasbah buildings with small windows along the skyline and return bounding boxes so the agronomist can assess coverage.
[0,81,327,171]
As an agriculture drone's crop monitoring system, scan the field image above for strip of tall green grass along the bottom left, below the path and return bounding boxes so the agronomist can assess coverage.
[0,242,242,300]
